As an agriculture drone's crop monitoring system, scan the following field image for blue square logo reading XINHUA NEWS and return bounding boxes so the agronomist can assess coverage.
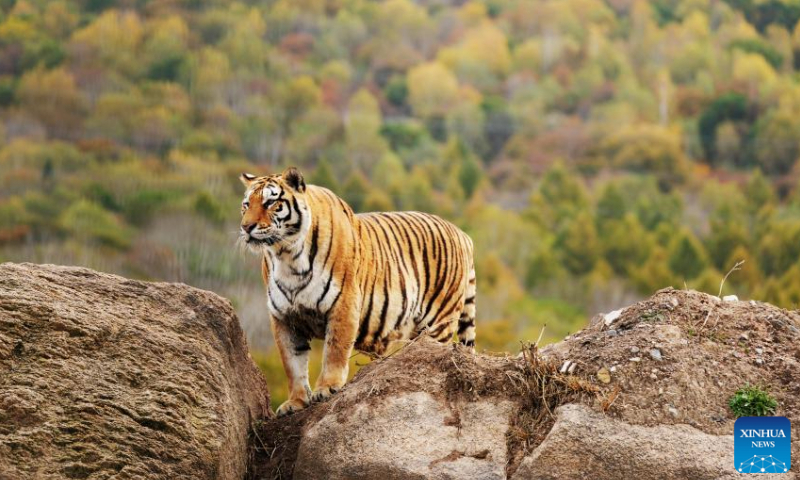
[733,417,792,473]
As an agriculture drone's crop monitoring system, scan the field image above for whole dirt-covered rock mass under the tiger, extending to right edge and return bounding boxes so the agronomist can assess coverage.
[251,289,800,480]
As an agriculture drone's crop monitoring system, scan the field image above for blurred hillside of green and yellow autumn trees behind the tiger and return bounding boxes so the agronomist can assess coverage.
[0,0,800,386]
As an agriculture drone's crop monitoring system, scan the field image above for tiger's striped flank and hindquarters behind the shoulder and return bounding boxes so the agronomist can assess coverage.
[355,212,475,353]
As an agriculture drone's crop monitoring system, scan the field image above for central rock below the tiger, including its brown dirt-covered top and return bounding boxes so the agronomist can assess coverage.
[292,341,518,480]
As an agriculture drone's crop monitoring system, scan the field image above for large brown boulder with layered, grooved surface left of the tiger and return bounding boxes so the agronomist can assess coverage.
[0,264,270,479]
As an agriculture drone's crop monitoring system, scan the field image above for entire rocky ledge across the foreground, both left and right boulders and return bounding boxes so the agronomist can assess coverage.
[0,264,800,480]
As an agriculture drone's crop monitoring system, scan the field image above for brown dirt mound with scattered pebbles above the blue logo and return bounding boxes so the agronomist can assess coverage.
[542,288,800,436]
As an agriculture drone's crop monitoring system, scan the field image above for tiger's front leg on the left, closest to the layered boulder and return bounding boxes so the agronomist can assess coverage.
[270,317,311,417]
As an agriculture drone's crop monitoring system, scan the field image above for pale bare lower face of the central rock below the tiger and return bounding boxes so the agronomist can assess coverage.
[293,392,511,479]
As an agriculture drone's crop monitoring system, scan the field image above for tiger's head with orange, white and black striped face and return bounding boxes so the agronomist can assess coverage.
[239,167,311,251]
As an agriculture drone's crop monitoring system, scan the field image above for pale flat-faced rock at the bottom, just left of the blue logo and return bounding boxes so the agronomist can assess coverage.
[511,404,733,480]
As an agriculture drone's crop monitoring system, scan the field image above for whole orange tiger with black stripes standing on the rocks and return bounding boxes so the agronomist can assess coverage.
[240,168,475,416]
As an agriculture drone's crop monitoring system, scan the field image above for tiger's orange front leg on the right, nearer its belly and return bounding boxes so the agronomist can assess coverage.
[311,293,359,402]
